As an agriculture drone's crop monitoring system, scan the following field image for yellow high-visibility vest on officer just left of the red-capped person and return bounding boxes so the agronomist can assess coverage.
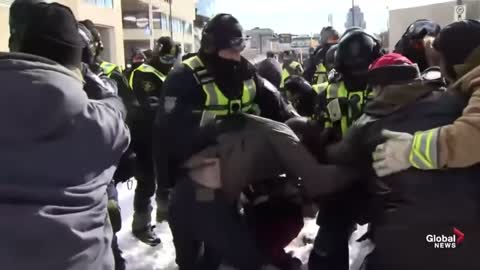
[325,82,368,136]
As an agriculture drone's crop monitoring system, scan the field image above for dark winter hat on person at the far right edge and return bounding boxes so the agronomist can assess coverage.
[433,20,480,78]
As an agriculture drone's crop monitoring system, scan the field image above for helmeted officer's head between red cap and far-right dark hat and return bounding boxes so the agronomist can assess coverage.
[394,19,441,72]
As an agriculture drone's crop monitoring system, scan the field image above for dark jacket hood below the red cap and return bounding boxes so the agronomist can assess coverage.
[365,80,435,117]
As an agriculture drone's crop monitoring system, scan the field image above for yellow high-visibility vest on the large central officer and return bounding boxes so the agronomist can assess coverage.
[183,56,260,126]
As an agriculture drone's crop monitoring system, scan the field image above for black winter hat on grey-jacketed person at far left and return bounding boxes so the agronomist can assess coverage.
[20,3,84,67]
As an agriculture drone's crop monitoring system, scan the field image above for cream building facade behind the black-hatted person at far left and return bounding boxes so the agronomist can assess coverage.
[0,0,125,66]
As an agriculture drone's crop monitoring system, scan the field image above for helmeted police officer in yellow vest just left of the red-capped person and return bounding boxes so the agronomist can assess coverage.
[309,30,382,269]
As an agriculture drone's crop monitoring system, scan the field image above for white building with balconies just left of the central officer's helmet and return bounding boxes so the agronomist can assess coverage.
[122,0,195,62]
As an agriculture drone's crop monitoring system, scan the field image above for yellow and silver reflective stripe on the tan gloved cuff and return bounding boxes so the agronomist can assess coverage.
[409,128,440,170]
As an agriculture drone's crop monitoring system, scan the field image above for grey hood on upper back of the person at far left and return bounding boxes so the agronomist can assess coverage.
[0,53,88,142]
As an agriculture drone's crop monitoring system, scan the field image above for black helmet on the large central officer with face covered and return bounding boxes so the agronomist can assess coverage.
[201,13,246,54]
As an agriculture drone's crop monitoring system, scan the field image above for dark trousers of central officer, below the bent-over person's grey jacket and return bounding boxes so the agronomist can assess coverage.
[169,177,261,270]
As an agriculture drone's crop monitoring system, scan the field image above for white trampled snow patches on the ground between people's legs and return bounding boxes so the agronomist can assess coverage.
[117,180,371,270]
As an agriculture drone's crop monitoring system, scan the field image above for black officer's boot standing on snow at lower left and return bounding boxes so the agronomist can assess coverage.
[132,212,162,247]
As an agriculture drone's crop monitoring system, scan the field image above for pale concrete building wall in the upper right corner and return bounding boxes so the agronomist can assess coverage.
[389,1,480,50]
